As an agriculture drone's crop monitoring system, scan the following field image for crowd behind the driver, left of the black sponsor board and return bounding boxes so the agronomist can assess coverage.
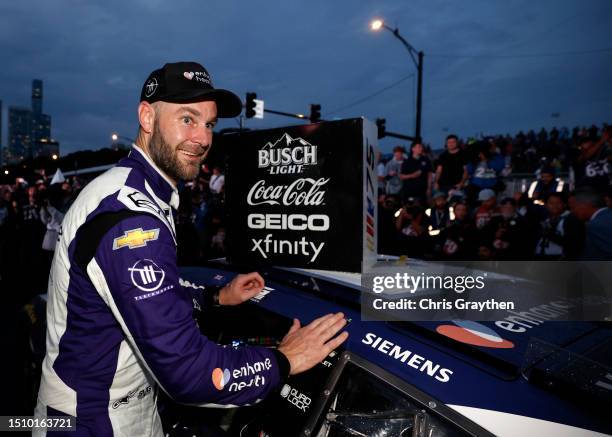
[0,165,225,301]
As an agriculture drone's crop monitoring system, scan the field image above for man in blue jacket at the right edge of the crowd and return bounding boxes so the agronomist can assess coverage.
[572,187,612,260]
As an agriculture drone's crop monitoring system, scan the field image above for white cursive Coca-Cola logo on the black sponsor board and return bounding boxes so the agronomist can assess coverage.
[247,178,329,206]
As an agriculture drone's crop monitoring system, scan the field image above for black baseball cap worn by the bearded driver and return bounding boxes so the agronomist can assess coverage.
[140,62,242,118]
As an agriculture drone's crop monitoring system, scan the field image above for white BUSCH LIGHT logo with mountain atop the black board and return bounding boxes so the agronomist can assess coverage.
[258,134,317,174]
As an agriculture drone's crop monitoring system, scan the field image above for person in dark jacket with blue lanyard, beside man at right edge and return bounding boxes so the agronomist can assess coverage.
[535,192,584,260]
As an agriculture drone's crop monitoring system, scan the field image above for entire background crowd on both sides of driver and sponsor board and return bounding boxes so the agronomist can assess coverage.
[0,121,612,304]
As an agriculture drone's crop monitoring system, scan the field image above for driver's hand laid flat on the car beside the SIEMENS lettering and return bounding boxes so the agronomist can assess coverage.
[278,313,348,375]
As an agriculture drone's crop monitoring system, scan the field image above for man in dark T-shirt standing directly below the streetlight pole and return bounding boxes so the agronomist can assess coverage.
[400,143,431,205]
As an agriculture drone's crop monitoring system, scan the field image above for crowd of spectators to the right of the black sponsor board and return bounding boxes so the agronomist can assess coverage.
[378,125,612,260]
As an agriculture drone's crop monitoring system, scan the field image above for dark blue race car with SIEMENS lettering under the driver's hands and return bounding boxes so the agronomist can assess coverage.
[21,262,612,437]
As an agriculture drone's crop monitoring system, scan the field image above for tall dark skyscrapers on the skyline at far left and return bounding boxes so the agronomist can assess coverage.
[5,79,59,163]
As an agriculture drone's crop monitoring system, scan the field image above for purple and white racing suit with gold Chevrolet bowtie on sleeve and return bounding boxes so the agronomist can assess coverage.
[34,146,289,437]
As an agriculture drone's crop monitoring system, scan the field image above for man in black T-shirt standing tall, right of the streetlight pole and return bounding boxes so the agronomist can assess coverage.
[434,135,468,193]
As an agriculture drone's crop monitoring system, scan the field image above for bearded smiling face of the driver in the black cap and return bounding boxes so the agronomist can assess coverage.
[149,102,217,181]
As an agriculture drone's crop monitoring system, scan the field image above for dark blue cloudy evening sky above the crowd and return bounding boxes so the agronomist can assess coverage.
[0,0,612,154]
